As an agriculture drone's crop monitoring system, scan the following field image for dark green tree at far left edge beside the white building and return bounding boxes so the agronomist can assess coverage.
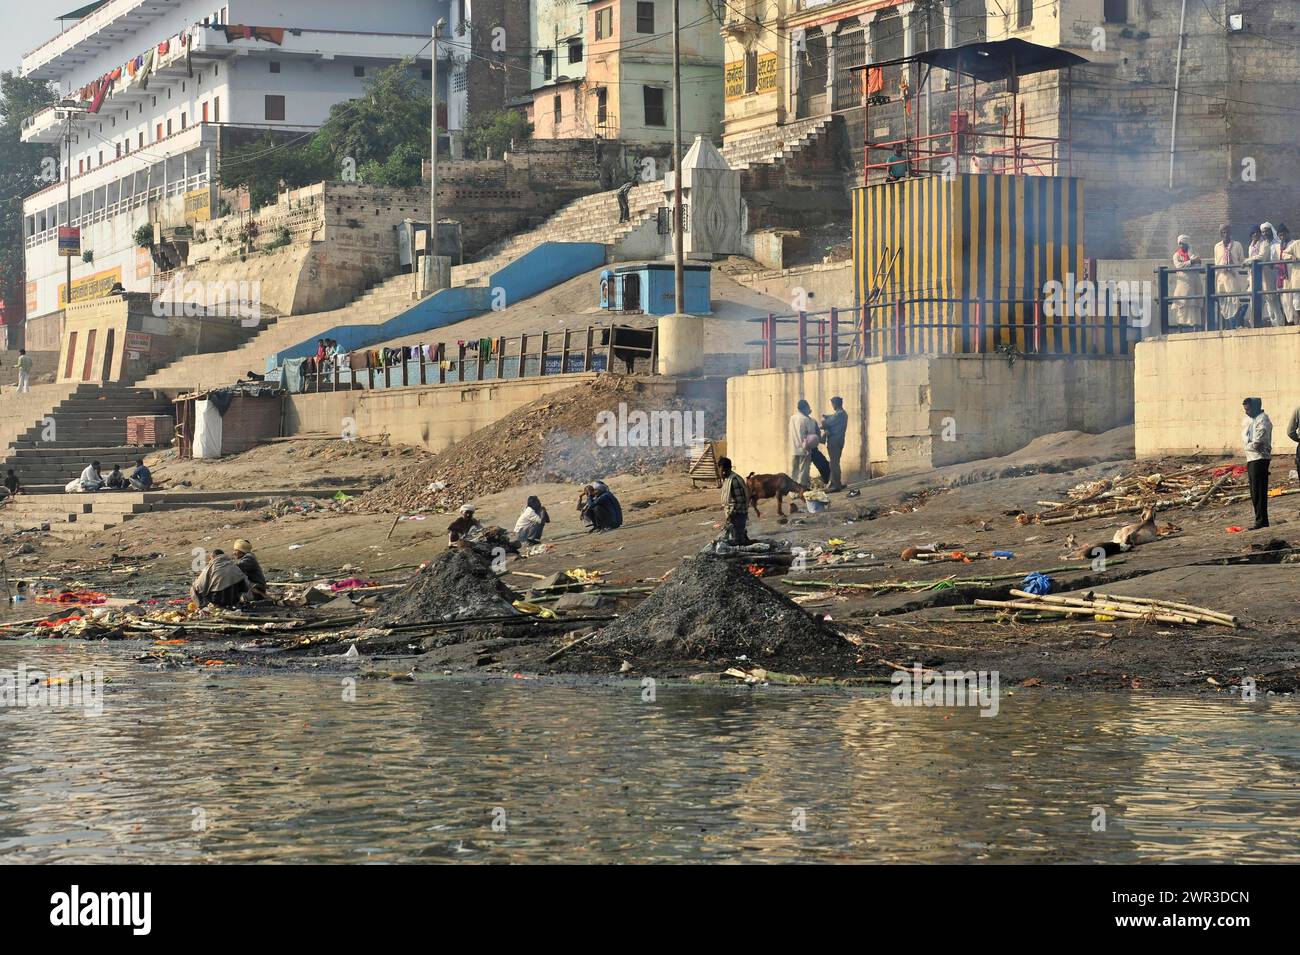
[0,71,59,314]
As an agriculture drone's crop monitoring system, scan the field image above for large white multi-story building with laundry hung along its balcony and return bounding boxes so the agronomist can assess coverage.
[22,0,472,318]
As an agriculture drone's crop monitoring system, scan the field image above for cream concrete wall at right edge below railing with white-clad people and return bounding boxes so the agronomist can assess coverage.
[1134,327,1300,466]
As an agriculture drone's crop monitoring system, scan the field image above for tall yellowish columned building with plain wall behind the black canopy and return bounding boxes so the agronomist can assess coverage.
[723,0,1300,257]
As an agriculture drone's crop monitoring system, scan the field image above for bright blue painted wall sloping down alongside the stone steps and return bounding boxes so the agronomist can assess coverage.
[267,242,608,372]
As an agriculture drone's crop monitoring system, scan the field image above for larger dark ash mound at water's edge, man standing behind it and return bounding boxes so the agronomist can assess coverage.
[585,555,855,669]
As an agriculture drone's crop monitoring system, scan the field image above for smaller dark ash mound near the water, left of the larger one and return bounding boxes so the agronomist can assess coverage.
[371,547,517,626]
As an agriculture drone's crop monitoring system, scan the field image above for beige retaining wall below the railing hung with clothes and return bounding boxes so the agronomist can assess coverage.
[285,374,595,451]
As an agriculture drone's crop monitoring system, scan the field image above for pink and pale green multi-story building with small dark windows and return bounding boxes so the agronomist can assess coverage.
[532,0,723,144]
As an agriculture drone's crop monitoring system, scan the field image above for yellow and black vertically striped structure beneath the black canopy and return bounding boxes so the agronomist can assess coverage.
[853,174,1128,355]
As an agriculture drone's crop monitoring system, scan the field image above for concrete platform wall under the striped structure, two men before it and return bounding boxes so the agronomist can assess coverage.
[727,355,1132,481]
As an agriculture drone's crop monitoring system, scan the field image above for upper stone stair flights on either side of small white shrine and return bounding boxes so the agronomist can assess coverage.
[451,116,833,285]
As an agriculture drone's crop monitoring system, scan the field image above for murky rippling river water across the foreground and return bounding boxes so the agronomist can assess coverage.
[0,643,1300,863]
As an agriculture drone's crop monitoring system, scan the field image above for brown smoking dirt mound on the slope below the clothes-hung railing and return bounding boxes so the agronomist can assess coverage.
[354,377,727,513]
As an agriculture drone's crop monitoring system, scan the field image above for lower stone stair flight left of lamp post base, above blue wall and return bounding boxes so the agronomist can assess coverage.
[138,274,416,388]
